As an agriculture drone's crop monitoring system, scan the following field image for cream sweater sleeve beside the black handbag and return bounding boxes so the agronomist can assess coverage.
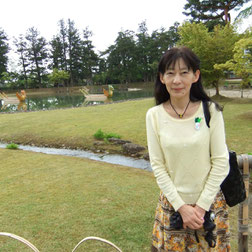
[196,105,229,211]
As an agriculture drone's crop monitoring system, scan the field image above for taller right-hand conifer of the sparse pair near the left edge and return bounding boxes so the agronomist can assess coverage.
[25,27,48,87]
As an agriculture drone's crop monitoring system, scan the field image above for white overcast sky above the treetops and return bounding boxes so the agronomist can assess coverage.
[0,0,252,51]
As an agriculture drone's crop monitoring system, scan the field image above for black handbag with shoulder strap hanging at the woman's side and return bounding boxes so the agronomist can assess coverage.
[203,101,247,207]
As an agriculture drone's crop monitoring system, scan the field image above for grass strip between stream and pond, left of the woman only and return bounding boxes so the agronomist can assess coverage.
[0,99,153,156]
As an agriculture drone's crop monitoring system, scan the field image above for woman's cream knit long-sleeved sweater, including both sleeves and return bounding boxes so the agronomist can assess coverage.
[146,102,229,211]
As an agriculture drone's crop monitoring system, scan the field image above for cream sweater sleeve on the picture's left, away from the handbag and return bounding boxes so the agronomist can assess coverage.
[146,110,185,211]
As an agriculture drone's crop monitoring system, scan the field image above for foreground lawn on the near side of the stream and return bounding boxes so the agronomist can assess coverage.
[0,149,159,252]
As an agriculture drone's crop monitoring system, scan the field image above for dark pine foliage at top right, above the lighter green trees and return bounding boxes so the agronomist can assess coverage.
[183,0,250,30]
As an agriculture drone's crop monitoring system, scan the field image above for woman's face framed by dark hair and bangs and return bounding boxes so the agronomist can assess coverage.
[160,58,200,98]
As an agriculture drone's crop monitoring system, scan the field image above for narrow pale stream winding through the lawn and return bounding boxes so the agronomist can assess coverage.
[0,143,152,171]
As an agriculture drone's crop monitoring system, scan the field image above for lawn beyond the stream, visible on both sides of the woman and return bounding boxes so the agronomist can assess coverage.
[0,99,252,154]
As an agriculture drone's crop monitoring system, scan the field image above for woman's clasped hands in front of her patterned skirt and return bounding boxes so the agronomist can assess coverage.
[178,204,204,229]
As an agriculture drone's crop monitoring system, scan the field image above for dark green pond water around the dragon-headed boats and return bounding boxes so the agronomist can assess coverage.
[0,83,153,113]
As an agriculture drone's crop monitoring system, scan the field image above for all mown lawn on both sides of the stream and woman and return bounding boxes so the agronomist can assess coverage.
[0,96,252,252]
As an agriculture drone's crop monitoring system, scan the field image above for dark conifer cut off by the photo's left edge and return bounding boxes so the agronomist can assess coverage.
[0,29,9,78]
